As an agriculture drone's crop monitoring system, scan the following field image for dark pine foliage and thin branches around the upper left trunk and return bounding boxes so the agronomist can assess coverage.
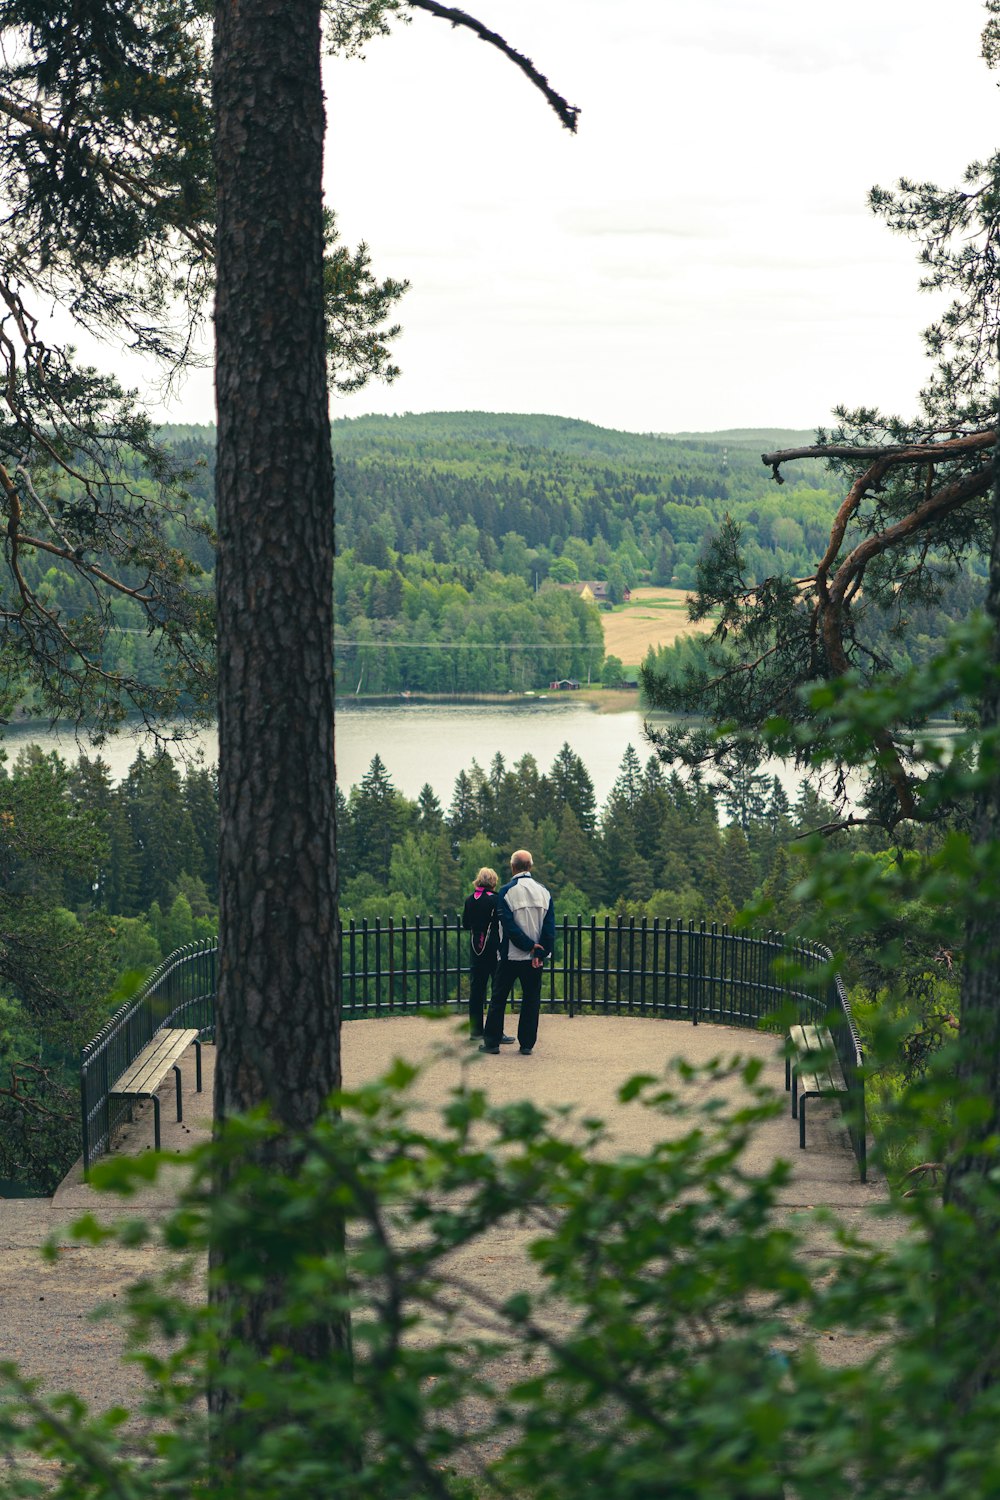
[0,0,405,732]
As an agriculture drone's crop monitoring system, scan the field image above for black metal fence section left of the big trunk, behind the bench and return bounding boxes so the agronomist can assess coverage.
[79,941,216,1175]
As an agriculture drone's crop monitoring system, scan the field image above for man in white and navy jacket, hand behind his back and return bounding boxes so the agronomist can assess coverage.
[480,849,556,1058]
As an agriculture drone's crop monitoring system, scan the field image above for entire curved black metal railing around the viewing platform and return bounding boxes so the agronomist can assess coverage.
[81,917,865,1181]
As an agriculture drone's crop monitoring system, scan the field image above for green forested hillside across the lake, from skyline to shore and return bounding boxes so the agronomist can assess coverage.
[15,413,982,693]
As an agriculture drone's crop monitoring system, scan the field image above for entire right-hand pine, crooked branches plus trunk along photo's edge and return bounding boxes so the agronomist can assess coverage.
[645,14,1000,1242]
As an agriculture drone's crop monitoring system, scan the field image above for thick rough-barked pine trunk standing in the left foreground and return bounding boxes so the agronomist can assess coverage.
[214,0,345,1407]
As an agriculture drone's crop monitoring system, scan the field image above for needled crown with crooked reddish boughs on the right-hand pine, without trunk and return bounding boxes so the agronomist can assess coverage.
[643,124,1000,828]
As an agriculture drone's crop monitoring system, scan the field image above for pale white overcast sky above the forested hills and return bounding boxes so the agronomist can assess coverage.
[144,0,1000,432]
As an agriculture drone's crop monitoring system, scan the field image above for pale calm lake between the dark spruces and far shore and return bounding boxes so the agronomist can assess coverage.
[3,698,799,809]
